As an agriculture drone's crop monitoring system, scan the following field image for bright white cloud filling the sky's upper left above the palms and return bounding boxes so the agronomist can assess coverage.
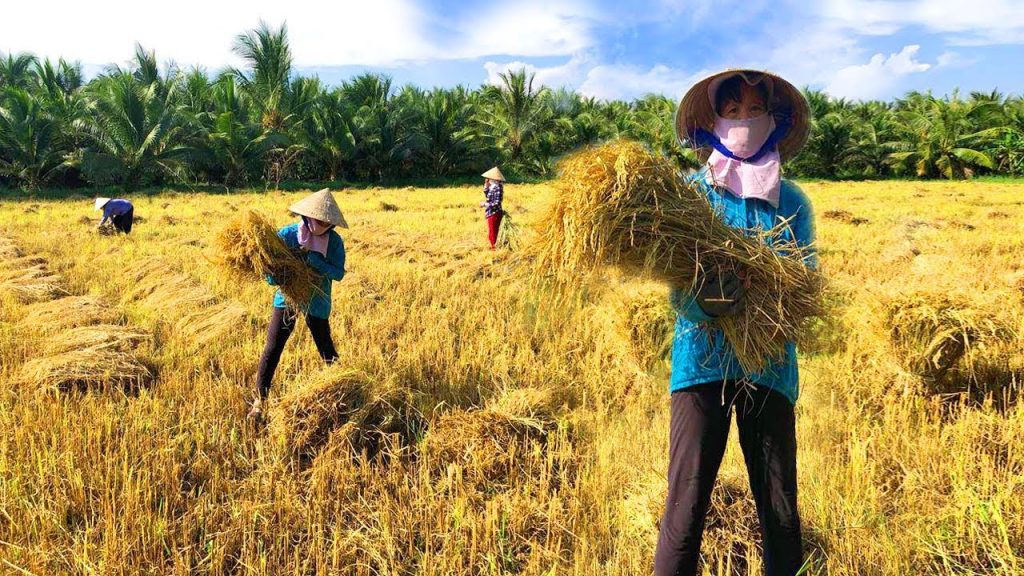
[0,0,432,68]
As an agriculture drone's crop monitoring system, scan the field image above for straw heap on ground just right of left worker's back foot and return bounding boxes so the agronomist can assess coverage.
[270,368,418,459]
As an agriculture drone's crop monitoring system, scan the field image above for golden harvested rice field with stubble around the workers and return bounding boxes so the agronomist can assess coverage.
[0,180,1024,576]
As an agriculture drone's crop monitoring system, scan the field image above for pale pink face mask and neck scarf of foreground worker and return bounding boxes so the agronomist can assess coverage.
[708,114,781,208]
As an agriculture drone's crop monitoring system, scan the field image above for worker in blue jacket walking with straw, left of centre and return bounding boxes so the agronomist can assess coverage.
[249,189,348,419]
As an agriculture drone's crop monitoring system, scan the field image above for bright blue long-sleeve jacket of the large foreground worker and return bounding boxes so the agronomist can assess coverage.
[669,173,817,404]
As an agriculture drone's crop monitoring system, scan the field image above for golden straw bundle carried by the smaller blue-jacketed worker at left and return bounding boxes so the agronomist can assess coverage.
[214,210,322,308]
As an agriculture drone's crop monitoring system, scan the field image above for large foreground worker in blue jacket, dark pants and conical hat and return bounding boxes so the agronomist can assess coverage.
[654,70,816,576]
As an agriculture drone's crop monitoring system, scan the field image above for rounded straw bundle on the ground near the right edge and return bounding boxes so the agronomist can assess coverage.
[888,292,1015,380]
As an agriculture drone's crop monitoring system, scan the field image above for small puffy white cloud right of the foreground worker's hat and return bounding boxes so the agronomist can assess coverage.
[825,45,932,99]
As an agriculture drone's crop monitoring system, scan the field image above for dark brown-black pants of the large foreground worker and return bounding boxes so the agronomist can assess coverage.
[654,382,803,576]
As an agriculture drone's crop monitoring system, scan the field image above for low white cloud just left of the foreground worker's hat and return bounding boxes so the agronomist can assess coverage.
[578,64,707,99]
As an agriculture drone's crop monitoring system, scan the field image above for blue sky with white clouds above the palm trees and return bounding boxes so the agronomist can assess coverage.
[0,0,1024,99]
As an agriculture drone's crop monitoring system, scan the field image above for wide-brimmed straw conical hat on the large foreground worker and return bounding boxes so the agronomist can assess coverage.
[676,69,811,161]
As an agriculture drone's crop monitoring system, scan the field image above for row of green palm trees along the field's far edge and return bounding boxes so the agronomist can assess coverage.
[0,24,1024,189]
